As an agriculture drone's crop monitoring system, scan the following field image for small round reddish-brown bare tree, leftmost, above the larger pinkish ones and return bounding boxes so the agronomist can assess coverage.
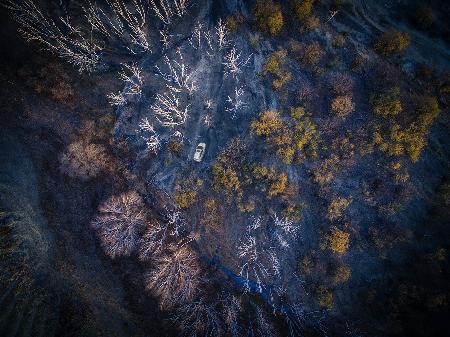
[59,140,112,181]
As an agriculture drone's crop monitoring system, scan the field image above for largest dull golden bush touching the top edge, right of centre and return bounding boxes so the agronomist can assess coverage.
[253,0,284,35]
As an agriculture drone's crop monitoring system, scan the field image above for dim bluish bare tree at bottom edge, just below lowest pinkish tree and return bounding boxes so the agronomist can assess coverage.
[173,298,223,337]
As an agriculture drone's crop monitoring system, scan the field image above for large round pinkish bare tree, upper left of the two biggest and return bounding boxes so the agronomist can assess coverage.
[91,191,146,258]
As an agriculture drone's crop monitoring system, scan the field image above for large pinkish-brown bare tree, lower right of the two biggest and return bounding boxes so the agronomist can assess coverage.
[145,245,201,309]
